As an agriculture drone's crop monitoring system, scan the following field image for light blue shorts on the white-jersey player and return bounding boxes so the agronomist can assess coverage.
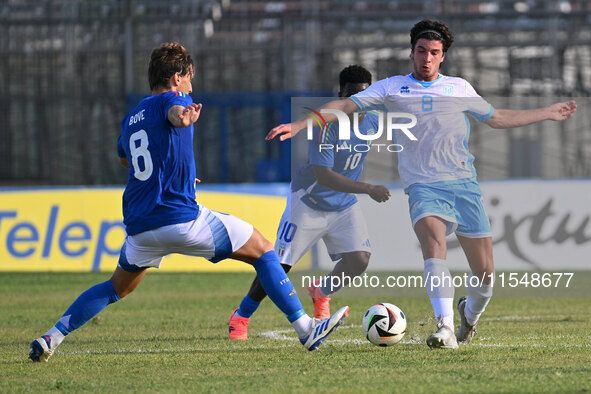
[404,179,492,238]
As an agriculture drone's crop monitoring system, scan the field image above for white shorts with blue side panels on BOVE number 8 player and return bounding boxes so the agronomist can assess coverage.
[119,205,253,272]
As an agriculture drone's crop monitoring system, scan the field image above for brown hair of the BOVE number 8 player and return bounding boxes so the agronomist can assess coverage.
[148,42,194,90]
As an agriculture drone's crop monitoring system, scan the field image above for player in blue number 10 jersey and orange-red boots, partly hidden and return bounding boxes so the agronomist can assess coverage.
[229,65,390,340]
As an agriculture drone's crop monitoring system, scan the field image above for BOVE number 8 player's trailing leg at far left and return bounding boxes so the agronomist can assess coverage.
[29,267,145,362]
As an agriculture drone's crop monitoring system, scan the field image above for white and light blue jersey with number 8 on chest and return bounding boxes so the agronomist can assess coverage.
[351,74,494,187]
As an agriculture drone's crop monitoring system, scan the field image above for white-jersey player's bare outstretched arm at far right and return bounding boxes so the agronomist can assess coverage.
[486,100,577,129]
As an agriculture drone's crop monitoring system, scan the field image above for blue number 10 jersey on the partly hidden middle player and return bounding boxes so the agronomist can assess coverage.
[291,111,378,211]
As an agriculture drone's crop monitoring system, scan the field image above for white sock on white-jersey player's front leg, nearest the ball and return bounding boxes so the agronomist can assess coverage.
[424,258,454,330]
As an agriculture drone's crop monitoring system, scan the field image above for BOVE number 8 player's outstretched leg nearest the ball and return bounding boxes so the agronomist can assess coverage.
[231,229,349,350]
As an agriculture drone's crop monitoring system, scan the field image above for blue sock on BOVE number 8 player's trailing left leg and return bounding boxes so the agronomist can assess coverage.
[55,280,119,335]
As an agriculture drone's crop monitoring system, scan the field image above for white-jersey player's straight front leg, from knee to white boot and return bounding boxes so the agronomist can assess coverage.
[414,216,458,349]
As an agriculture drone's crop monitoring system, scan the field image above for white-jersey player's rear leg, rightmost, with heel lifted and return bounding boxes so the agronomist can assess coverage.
[456,235,494,343]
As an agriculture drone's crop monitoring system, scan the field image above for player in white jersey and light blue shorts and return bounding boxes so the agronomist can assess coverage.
[267,20,577,349]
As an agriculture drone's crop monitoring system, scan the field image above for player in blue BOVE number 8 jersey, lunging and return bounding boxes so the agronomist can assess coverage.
[29,43,348,361]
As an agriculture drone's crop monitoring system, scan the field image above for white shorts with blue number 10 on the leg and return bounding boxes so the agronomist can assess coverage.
[275,192,371,266]
